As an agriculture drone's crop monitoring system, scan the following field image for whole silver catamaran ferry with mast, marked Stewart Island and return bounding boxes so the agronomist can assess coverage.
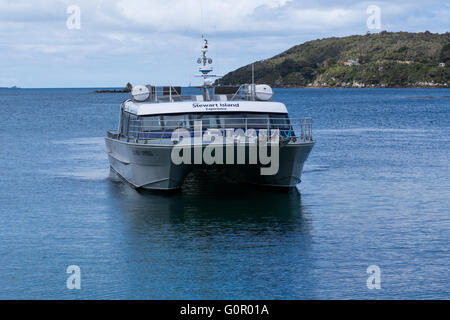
[105,39,314,190]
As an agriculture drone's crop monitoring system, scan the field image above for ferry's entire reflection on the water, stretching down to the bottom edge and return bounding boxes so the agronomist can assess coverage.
[104,172,314,299]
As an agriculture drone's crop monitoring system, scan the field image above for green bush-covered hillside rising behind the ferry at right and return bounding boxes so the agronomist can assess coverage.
[218,31,450,87]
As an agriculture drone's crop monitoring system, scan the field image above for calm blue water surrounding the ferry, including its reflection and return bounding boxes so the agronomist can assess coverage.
[0,89,450,299]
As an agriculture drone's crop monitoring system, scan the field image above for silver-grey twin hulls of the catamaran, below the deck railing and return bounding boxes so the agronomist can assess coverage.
[105,138,314,190]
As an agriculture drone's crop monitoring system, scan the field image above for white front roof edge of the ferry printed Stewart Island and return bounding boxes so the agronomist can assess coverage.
[123,100,288,116]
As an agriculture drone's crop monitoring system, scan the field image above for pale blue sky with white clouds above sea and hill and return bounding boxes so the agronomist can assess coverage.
[0,0,450,88]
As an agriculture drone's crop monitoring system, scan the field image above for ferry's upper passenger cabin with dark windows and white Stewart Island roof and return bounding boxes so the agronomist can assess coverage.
[108,86,312,143]
